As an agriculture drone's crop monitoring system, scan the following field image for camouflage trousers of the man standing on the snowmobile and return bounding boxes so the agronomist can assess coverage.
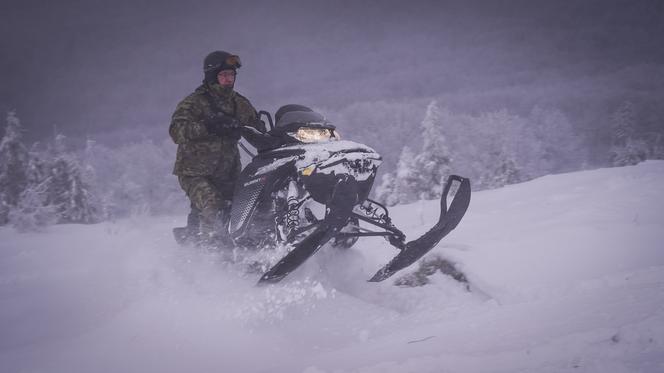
[178,156,240,241]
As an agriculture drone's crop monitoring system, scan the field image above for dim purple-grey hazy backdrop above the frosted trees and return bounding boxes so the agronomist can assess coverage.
[0,0,664,144]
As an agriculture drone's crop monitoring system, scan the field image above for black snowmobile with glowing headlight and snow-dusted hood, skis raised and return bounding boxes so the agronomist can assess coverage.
[174,105,471,284]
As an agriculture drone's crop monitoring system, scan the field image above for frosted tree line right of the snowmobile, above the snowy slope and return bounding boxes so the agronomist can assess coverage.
[375,100,664,206]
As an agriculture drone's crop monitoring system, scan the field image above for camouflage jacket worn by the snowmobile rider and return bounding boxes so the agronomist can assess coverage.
[169,84,265,176]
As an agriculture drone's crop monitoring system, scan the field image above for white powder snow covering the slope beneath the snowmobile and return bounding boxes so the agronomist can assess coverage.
[0,161,664,373]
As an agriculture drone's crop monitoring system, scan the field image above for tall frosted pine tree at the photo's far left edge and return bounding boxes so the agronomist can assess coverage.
[0,111,28,225]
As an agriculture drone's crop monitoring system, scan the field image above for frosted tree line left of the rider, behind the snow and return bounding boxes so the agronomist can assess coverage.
[0,112,184,231]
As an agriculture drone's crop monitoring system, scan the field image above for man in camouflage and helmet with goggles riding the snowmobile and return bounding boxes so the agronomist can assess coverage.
[169,51,265,246]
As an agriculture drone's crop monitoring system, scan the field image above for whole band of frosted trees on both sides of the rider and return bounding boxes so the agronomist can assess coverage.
[0,100,664,230]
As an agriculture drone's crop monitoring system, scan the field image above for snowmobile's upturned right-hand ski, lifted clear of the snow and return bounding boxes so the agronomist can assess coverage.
[369,175,470,282]
